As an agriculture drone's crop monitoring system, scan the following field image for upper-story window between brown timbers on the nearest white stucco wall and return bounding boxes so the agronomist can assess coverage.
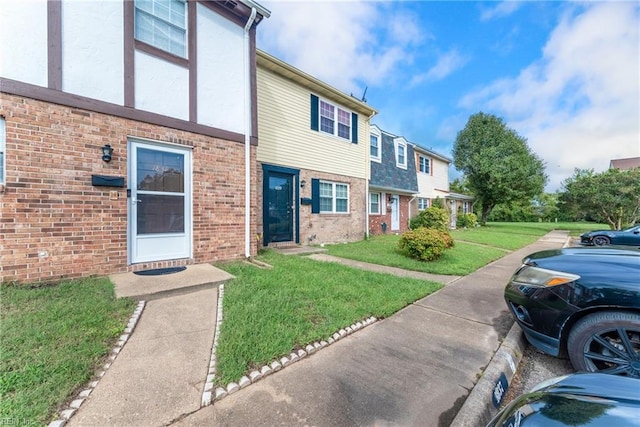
[135,0,187,58]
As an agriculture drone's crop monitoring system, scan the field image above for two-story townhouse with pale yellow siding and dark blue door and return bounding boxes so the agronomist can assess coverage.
[257,50,376,247]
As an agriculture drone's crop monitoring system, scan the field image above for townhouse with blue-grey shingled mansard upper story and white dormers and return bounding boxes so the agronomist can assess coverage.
[369,125,418,235]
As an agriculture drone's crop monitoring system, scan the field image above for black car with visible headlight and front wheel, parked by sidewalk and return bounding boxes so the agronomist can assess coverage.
[504,247,640,378]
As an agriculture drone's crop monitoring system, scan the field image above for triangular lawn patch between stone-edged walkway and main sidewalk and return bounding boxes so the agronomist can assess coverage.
[216,251,442,385]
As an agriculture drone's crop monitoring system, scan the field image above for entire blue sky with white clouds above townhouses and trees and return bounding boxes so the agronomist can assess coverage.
[258,0,640,191]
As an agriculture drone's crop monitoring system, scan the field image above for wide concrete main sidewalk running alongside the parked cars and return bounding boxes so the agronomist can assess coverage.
[172,232,567,426]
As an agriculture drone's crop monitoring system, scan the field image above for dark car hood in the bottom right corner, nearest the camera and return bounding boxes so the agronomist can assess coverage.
[487,373,640,427]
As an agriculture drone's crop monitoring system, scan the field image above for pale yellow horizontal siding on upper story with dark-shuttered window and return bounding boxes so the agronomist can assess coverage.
[257,65,369,179]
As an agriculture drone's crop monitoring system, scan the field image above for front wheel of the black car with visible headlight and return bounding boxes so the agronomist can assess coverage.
[567,311,640,378]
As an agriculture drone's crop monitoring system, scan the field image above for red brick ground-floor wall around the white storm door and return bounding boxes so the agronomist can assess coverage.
[0,93,257,282]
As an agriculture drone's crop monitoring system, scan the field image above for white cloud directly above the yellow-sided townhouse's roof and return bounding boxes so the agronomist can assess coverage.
[258,1,428,93]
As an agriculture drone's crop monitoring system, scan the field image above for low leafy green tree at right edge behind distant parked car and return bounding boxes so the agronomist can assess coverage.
[560,168,640,230]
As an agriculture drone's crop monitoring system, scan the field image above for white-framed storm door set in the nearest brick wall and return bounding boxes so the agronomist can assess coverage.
[128,140,192,264]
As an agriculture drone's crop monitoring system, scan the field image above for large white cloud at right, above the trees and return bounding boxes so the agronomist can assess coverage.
[460,2,640,191]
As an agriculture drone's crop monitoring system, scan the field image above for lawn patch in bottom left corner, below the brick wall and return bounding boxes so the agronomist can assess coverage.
[0,278,135,425]
